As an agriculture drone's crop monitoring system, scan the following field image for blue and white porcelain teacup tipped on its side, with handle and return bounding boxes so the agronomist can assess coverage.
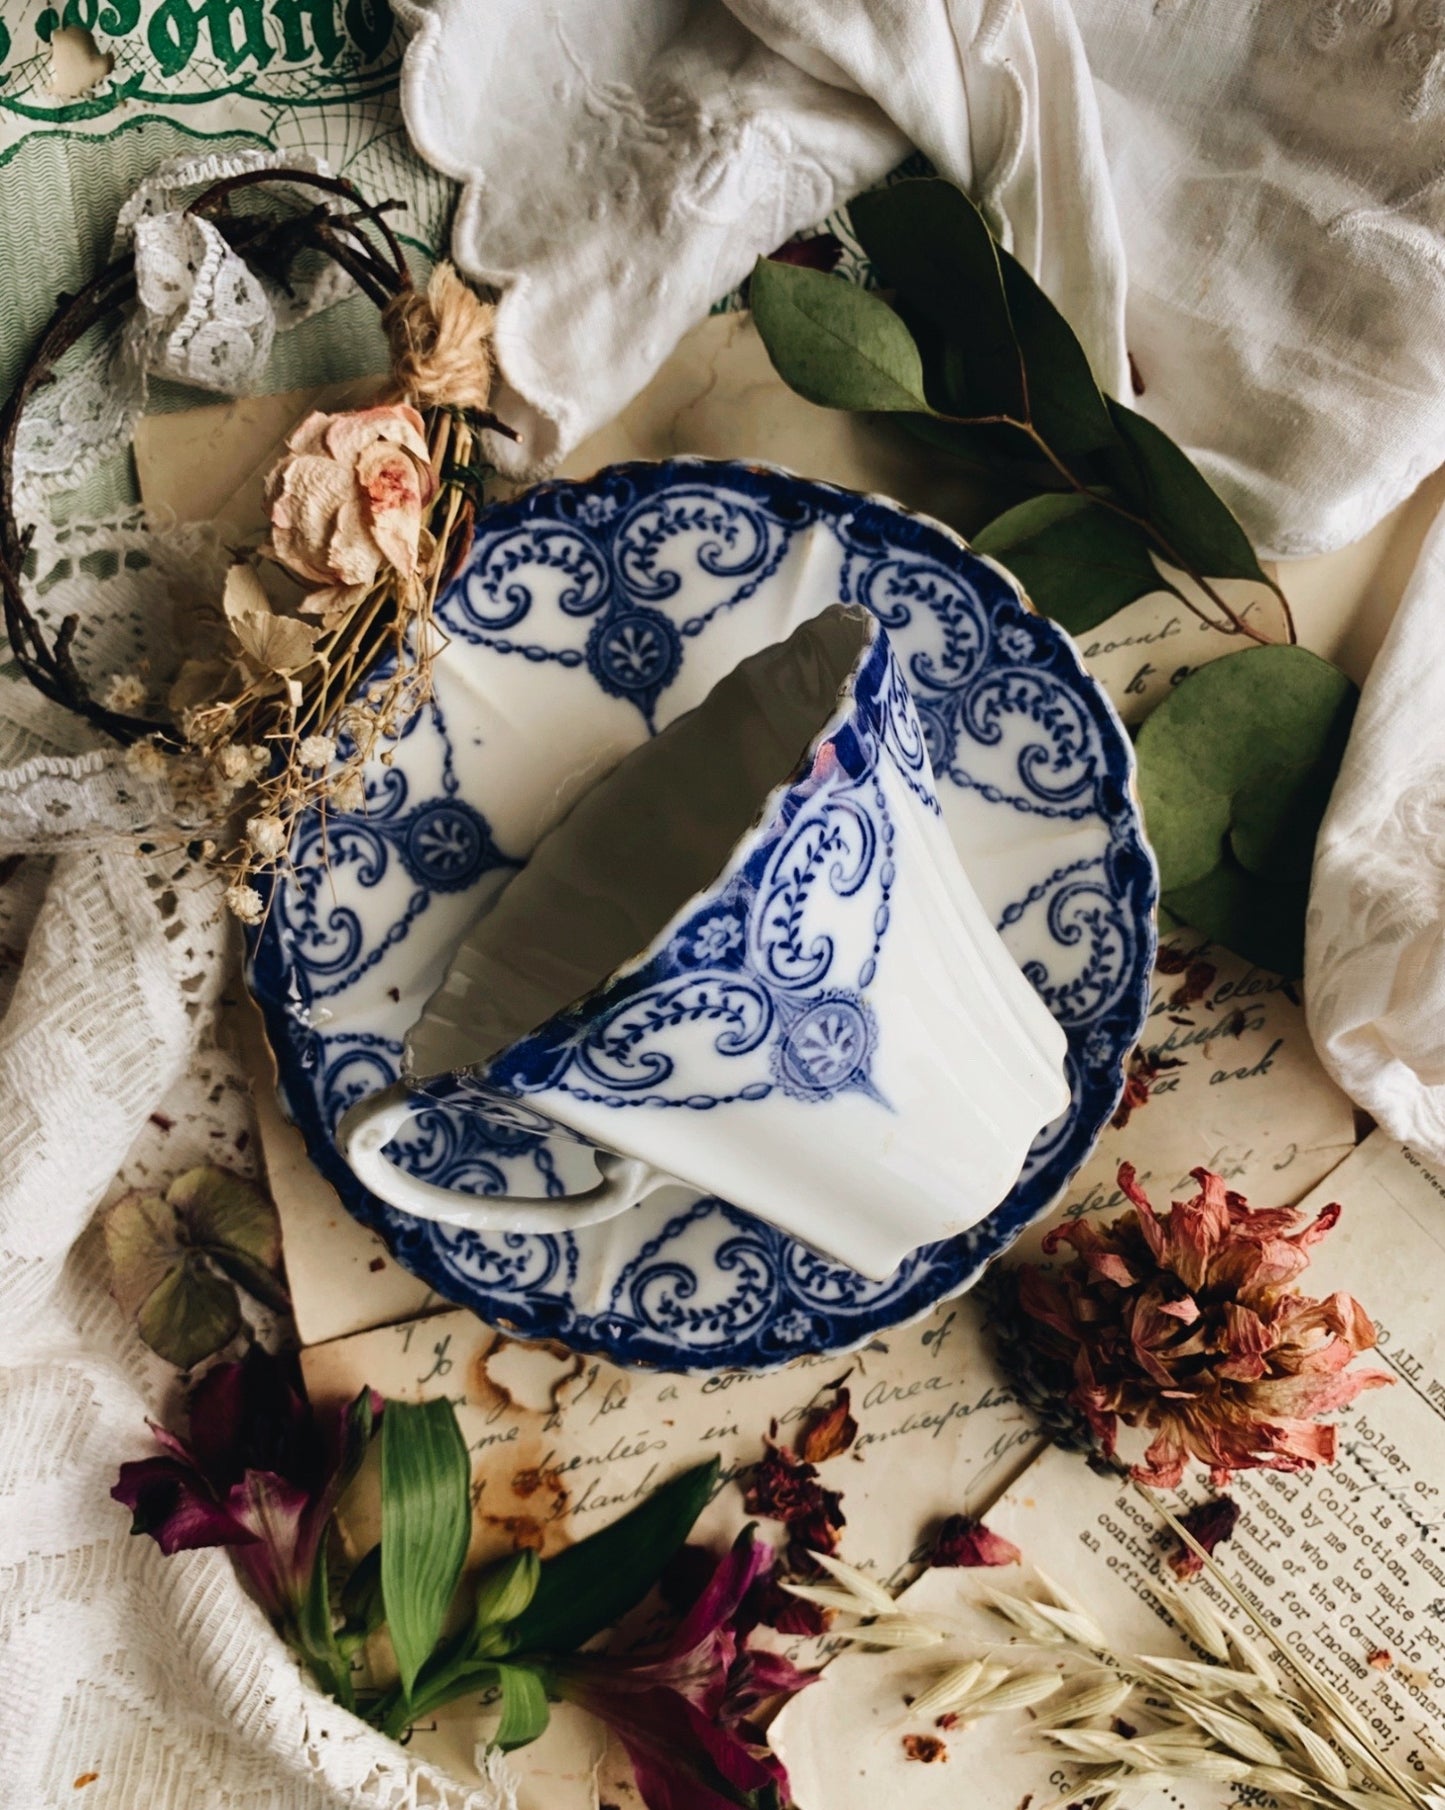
[339,606,1068,1278]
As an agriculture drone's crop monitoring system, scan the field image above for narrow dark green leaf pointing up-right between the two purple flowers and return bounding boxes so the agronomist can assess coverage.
[507,1455,719,1653]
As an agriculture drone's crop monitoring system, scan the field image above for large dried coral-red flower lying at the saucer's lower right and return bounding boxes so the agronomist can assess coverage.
[1018,1164,1391,1490]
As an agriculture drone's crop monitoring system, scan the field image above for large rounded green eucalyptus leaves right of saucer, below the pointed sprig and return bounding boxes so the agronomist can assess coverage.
[1137,646,1358,979]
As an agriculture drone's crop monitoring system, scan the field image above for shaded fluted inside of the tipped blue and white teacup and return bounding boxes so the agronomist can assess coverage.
[406,605,878,1077]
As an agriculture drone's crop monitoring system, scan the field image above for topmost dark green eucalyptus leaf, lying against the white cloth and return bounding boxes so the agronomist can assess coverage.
[847,176,1029,420]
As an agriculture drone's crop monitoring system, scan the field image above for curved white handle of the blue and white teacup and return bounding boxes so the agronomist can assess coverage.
[337,1081,672,1233]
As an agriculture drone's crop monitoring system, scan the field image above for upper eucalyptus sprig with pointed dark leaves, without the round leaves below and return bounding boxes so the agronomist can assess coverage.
[750,177,1295,643]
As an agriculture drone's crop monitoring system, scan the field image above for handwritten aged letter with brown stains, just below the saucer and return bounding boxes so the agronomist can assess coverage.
[302,1300,1039,1810]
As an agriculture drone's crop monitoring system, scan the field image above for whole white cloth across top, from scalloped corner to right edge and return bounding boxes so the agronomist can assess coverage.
[400,0,1445,556]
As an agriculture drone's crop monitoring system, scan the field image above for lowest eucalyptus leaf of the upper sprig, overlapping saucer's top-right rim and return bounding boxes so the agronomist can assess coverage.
[972,494,1172,635]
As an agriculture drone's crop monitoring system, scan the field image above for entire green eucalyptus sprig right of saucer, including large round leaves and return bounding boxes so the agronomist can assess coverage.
[750,177,1356,977]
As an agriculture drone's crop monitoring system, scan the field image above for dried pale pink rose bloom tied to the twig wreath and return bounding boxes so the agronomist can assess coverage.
[266,402,436,617]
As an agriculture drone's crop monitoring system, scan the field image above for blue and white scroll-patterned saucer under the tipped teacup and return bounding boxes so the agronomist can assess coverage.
[250,460,1155,1370]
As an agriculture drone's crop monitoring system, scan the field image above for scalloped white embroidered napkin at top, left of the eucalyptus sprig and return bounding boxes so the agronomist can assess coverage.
[397,0,1126,474]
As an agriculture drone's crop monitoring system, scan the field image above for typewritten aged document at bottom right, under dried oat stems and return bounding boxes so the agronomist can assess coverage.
[775,1131,1445,1810]
